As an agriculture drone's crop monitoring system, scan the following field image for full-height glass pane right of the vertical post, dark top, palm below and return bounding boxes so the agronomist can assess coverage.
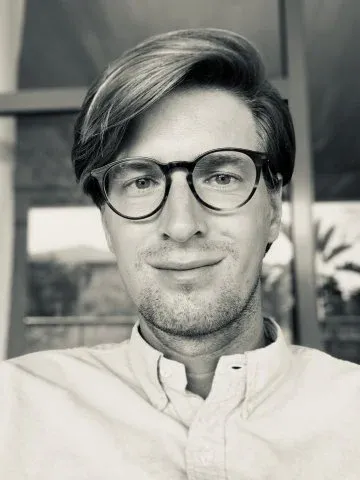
[306,0,360,363]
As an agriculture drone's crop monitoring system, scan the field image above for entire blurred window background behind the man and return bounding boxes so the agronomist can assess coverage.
[0,0,360,363]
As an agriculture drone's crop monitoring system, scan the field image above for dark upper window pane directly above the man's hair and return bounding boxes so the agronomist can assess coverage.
[20,0,281,88]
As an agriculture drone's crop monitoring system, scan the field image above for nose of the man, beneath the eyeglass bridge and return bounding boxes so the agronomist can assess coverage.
[159,171,207,243]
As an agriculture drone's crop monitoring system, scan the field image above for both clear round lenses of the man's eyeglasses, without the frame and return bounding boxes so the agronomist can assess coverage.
[104,150,256,217]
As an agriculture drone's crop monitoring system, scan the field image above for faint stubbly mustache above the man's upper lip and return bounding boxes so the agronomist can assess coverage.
[138,240,239,262]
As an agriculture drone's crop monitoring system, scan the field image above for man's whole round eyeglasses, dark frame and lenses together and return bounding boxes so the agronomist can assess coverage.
[87,148,276,220]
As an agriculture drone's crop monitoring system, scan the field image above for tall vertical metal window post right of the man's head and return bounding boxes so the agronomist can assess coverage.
[279,0,323,349]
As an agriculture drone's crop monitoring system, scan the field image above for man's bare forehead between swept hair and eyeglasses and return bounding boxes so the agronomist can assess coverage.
[122,88,260,162]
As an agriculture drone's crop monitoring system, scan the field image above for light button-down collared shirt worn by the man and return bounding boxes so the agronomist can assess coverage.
[0,320,360,480]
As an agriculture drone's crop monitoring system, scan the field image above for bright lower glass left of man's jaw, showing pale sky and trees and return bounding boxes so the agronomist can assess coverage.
[26,207,135,351]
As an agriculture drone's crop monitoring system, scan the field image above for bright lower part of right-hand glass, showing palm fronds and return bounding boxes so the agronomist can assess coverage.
[314,201,360,363]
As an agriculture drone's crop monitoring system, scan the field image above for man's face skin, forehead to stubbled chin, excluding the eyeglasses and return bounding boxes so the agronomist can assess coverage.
[103,88,281,336]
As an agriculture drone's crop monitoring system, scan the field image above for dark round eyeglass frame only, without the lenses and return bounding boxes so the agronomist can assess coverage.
[83,147,273,220]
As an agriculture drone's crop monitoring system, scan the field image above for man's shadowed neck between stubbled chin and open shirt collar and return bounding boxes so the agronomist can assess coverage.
[140,298,266,398]
